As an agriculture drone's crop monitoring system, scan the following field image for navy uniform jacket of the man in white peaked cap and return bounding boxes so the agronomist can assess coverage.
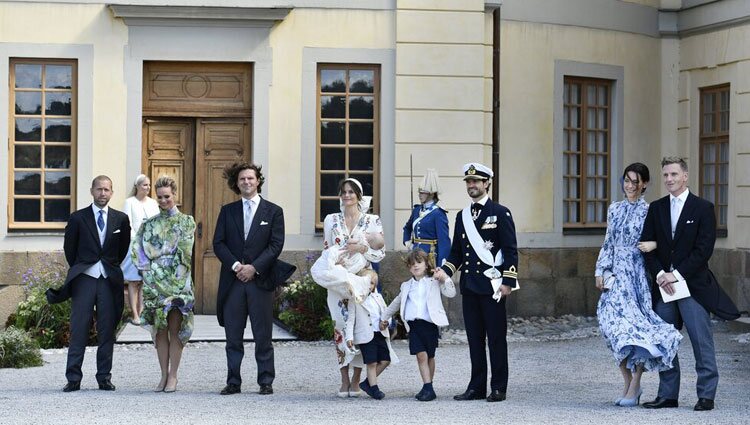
[443,199,518,295]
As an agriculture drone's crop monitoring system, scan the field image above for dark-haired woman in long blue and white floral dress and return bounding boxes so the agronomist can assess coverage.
[595,162,682,407]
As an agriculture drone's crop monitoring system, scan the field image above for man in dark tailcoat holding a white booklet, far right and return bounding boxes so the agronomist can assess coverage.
[641,157,738,410]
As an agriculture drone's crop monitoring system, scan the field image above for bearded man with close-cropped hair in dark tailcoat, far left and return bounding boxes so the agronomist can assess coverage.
[47,176,130,392]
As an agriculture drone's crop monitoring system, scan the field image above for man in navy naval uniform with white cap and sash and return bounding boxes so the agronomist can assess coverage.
[435,163,518,402]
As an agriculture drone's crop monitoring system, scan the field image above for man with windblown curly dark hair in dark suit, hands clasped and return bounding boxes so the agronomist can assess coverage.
[214,163,284,395]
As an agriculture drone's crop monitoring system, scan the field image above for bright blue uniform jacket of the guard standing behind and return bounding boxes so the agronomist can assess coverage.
[404,204,451,266]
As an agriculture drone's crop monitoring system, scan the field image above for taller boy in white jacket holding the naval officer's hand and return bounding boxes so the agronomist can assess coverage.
[383,248,456,401]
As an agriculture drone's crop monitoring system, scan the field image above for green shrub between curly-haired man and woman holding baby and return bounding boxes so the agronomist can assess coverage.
[275,256,333,341]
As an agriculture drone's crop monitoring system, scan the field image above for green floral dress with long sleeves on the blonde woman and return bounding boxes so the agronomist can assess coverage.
[131,207,195,345]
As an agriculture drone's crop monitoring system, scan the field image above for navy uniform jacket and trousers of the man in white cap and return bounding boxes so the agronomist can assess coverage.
[442,198,518,395]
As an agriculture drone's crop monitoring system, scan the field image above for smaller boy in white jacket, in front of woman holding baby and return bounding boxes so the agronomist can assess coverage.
[346,280,398,400]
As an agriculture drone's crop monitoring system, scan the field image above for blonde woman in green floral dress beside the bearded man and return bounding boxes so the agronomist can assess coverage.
[131,176,195,392]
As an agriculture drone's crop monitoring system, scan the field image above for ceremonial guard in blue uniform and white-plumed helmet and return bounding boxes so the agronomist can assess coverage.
[404,168,451,267]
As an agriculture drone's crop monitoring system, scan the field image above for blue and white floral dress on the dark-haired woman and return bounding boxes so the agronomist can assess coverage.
[595,198,682,371]
